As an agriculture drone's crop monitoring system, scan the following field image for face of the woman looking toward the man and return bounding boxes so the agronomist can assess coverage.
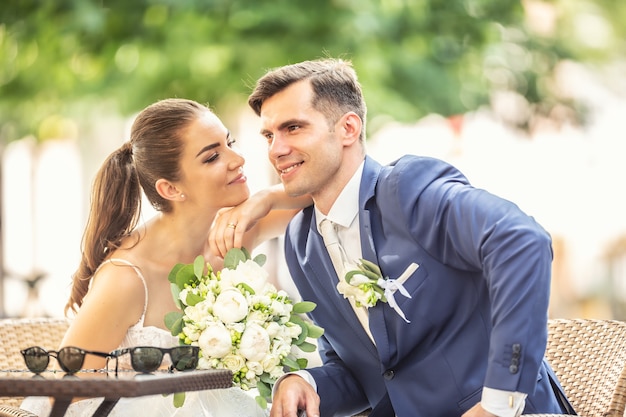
[178,111,250,209]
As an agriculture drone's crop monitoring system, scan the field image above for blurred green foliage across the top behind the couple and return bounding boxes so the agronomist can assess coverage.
[0,0,626,141]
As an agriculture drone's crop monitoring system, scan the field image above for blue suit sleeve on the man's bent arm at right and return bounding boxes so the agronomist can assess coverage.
[381,158,552,394]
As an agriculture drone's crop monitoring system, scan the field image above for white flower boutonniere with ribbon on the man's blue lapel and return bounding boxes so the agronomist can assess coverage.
[337,259,419,323]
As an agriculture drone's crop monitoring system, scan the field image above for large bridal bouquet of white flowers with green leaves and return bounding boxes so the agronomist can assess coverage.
[165,248,324,408]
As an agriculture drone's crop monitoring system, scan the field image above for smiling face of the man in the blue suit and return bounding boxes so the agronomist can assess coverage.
[261,81,343,203]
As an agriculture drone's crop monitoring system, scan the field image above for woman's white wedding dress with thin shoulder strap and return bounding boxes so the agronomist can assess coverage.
[20,259,269,417]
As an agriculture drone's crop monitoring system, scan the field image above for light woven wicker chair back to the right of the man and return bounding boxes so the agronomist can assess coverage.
[528,319,626,417]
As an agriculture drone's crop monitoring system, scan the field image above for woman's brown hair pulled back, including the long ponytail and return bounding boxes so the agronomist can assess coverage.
[65,99,210,314]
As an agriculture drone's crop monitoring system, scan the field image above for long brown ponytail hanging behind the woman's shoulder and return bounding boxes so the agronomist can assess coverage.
[65,142,141,314]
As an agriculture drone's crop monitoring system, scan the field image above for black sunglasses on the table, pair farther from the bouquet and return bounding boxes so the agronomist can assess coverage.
[20,346,110,374]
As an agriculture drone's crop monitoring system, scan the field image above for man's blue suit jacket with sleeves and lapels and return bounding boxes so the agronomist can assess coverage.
[285,156,564,417]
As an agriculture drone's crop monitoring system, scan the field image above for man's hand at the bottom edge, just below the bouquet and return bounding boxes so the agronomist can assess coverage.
[270,375,320,417]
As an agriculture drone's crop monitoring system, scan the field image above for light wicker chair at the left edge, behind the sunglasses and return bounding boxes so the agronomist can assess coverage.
[0,318,68,417]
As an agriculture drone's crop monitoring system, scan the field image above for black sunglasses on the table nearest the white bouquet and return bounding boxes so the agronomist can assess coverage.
[107,346,200,375]
